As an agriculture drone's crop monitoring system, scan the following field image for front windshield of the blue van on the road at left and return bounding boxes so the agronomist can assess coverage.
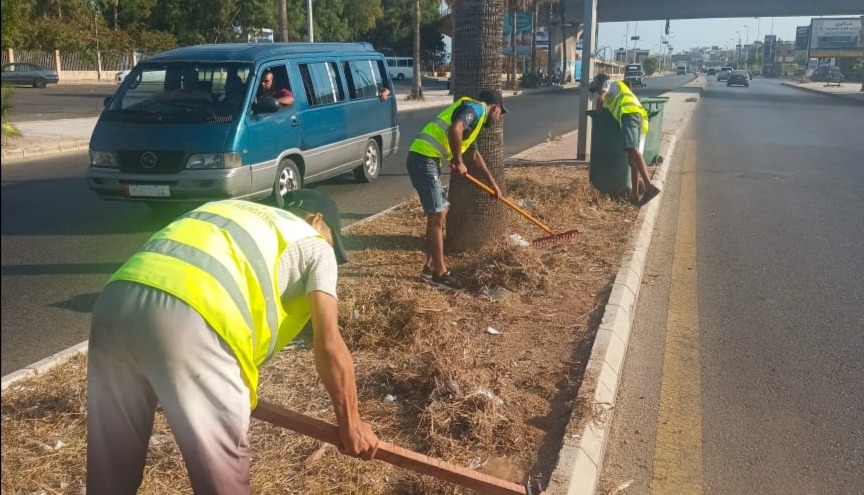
[103,62,252,124]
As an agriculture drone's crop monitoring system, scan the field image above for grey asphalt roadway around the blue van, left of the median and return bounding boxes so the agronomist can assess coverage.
[0,77,692,375]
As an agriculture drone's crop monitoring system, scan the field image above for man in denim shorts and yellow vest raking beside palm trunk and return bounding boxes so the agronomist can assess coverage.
[405,90,507,289]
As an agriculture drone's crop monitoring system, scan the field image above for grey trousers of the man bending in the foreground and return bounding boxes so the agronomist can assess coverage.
[87,282,250,495]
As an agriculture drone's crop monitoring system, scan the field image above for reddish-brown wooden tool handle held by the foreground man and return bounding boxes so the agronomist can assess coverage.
[252,400,527,495]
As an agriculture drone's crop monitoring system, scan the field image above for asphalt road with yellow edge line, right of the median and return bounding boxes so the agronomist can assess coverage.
[597,78,864,495]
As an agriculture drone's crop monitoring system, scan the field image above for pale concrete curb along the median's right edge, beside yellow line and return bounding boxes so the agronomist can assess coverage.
[547,79,704,495]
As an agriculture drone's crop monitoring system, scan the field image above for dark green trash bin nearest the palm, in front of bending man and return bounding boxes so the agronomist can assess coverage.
[585,110,632,197]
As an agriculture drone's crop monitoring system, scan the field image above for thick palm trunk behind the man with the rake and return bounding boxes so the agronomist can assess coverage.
[444,0,507,252]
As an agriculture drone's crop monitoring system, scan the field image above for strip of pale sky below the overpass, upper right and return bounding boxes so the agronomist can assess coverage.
[597,16,858,53]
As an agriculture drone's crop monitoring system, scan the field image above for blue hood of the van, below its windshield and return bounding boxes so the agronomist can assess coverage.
[90,118,235,156]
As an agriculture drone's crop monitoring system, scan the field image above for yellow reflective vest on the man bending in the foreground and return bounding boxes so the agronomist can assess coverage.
[109,200,322,409]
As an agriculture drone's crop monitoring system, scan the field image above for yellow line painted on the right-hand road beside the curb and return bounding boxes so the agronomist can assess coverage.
[651,141,704,495]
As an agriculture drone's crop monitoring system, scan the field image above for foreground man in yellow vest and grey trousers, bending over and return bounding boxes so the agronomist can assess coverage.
[87,189,378,495]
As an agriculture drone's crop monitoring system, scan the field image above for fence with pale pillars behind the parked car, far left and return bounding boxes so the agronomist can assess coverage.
[2,48,145,81]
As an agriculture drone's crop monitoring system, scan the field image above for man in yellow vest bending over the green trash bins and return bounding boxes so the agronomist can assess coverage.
[588,73,660,206]
